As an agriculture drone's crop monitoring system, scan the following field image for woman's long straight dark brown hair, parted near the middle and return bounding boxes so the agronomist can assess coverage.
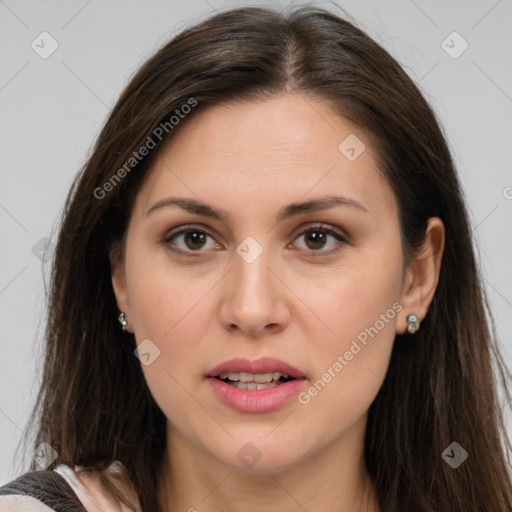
[18,6,512,512]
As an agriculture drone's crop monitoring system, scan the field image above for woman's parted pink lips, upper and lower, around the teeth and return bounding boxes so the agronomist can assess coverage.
[207,357,306,413]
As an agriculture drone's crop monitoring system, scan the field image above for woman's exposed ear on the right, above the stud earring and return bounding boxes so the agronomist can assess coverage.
[396,217,445,334]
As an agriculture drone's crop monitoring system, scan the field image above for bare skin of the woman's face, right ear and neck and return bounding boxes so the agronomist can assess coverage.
[112,94,444,512]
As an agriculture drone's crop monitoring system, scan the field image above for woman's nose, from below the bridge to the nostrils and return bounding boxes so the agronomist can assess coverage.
[220,242,290,336]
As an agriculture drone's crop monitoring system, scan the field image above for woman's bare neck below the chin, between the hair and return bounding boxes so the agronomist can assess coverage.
[159,417,380,512]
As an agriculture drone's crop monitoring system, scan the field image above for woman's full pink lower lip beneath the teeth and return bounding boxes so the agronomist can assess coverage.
[208,377,306,412]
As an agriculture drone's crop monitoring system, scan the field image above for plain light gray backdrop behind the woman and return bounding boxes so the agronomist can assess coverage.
[0,0,512,483]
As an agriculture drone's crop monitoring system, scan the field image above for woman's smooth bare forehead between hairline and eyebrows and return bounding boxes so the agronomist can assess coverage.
[135,94,396,220]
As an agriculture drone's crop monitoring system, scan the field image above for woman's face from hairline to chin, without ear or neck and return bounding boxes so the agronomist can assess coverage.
[113,95,418,471]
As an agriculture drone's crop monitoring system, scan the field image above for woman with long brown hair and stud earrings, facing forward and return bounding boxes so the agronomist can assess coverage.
[0,7,512,512]
